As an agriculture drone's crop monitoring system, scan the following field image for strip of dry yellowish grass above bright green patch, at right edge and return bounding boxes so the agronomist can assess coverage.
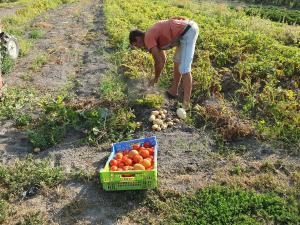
[213,157,300,195]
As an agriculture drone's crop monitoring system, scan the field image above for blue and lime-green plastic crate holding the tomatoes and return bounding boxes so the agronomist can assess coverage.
[100,137,158,191]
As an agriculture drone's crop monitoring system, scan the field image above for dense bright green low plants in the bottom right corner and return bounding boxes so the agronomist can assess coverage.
[174,187,300,225]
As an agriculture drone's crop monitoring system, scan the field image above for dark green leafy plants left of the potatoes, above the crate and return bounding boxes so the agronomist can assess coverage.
[29,96,138,149]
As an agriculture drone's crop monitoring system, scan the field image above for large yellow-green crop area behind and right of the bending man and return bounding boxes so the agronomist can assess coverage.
[104,0,300,151]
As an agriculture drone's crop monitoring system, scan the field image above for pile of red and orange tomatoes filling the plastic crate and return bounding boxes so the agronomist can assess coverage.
[109,142,154,171]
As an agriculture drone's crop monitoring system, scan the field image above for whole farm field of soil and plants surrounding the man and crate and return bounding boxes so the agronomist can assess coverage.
[0,0,300,225]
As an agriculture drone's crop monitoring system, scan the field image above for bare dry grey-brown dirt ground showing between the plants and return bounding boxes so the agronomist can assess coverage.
[0,0,297,225]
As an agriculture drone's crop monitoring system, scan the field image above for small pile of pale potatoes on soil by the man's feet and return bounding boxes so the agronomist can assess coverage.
[149,109,179,131]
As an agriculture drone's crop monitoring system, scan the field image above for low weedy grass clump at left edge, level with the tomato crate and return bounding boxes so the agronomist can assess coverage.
[0,157,64,199]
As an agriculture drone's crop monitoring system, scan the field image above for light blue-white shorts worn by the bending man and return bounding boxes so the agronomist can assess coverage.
[173,21,199,74]
